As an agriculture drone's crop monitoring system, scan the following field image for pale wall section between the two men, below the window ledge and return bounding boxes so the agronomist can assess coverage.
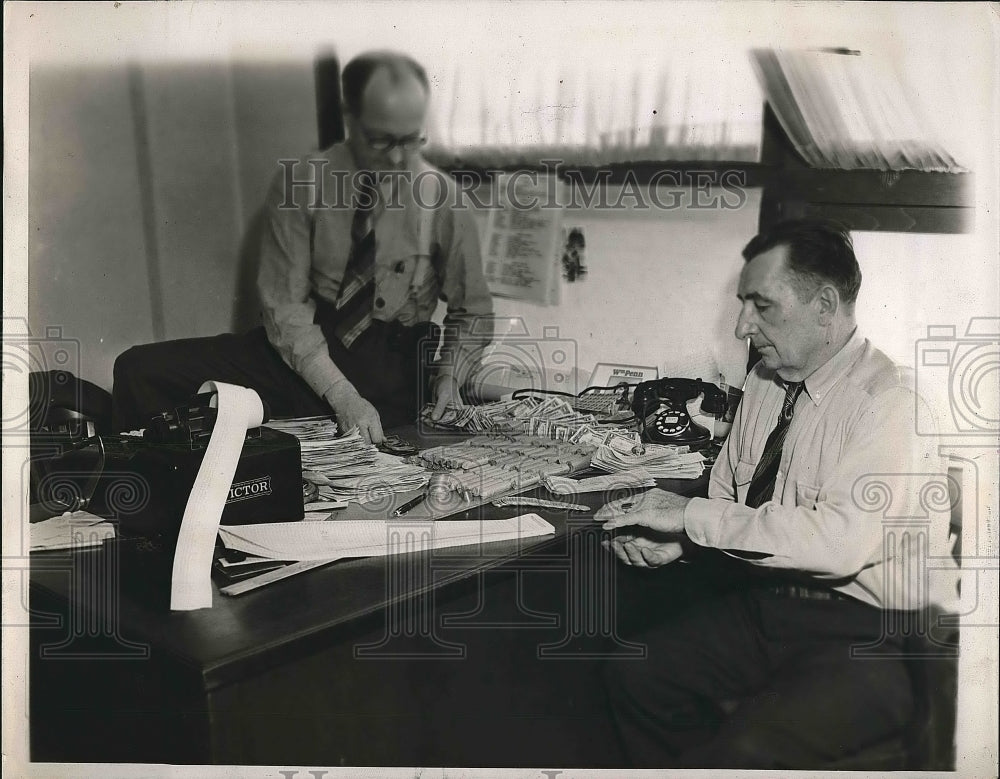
[464,189,760,389]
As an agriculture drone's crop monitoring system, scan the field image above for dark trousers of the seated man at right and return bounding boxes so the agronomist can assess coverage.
[604,589,913,769]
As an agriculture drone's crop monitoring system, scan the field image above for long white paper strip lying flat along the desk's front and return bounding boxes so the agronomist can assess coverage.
[219,514,555,561]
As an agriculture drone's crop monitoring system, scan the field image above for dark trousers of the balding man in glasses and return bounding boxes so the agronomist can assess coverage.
[112,322,439,431]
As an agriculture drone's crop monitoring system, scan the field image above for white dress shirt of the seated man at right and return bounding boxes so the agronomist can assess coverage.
[684,332,958,611]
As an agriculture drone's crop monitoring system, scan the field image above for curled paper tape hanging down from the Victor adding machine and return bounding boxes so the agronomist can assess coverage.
[170,381,264,611]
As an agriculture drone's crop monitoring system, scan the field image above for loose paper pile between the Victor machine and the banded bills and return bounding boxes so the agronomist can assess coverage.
[267,418,430,504]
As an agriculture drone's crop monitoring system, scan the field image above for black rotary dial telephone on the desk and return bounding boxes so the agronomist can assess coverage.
[632,378,726,450]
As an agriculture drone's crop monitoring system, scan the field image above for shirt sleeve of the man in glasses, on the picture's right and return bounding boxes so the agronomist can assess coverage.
[435,200,493,384]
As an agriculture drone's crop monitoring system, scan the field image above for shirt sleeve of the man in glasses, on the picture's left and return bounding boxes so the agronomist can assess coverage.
[257,172,344,397]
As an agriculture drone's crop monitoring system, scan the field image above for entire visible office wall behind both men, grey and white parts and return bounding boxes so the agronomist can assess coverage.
[29,61,997,400]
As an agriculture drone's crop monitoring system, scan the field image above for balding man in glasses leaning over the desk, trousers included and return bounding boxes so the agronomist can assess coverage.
[113,51,493,444]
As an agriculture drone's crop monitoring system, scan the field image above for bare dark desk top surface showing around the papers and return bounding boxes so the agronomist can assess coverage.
[31,429,708,689]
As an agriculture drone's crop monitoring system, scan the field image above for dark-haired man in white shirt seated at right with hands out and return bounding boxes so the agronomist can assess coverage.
[596,220,956,769]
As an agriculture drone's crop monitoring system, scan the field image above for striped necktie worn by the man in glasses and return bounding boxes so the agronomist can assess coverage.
[334,177,378,348]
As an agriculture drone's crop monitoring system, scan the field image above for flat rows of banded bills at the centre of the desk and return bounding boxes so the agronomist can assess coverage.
[418,435,596,500]
